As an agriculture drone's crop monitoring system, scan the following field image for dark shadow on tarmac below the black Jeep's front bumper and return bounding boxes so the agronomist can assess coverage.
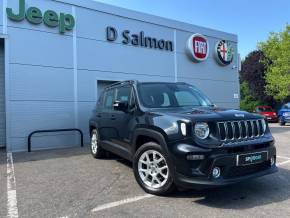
[163,168,290,209]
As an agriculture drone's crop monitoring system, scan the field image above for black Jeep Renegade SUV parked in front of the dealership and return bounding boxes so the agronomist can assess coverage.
[90,81,277,195]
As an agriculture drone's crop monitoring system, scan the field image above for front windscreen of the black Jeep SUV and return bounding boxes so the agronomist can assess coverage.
[138,83,212,108]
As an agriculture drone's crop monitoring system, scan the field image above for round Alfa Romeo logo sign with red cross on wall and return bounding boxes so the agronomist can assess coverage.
[215,40,234,65]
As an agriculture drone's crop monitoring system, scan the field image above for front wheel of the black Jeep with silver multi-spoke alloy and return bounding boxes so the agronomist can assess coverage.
[133,142,175,195]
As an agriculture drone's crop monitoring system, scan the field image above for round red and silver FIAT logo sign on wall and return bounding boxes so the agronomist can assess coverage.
[186,34,209,62]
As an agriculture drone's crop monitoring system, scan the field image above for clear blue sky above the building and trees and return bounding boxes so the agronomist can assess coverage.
[94,0,290,58]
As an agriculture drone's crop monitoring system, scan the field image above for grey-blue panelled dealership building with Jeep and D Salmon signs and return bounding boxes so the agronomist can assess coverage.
[0,0,239,151]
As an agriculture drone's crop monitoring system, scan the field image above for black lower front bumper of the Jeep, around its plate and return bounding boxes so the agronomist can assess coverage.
[169,142,278,188]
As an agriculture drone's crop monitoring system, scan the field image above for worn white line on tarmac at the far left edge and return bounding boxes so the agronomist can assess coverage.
[7,153,18,218]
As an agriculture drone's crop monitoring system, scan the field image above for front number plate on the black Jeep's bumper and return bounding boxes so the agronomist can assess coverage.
[237,151,268,166]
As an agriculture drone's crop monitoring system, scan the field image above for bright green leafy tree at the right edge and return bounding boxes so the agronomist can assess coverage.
[258,24,290,101]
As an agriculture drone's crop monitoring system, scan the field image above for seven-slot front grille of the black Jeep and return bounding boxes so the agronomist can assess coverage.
[217,119,265,142]
